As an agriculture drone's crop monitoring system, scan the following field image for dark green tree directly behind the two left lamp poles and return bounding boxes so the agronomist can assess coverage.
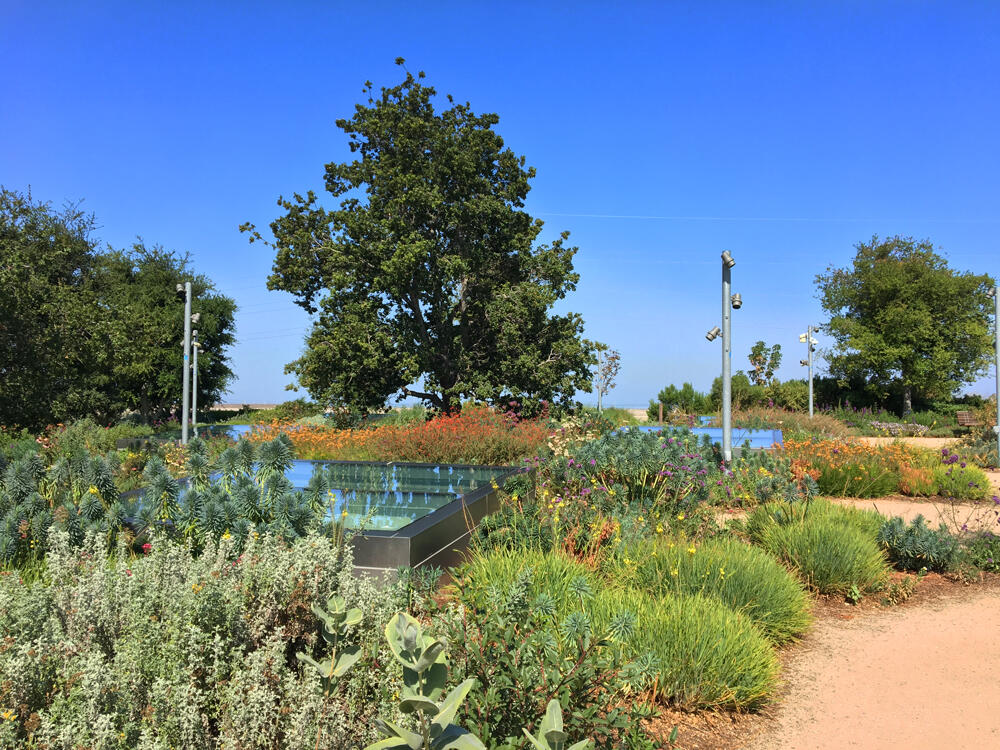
[100,242,236,422]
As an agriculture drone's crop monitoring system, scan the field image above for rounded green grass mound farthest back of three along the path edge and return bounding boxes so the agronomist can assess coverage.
[747,503,888,596]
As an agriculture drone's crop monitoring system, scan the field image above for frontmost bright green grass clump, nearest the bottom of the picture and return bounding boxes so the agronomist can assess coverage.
[590,589,779,710]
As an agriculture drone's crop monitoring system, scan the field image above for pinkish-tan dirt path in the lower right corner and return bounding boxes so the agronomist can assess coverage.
[747,588,1000,750]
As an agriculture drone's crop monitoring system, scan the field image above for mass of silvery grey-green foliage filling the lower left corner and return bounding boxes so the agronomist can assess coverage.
[0,532,399,750]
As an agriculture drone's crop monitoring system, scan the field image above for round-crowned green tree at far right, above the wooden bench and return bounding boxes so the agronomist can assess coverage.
[816,236,993,414]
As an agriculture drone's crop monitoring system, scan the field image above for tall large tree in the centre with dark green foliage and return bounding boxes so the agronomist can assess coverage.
[243,61,595,418]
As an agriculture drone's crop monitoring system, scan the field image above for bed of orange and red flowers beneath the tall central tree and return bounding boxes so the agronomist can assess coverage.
[250,406,549,465]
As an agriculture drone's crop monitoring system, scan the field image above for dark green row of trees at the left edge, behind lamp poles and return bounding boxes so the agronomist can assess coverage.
[0,188,236,430]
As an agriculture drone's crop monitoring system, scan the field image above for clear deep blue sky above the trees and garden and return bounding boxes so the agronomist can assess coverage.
[0,0,1000,406]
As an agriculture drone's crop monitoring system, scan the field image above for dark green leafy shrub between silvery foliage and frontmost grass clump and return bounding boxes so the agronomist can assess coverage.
[440,563,652,750]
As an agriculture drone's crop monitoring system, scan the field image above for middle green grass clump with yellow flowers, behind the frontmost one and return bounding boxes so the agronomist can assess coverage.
[620,536,811,643]
